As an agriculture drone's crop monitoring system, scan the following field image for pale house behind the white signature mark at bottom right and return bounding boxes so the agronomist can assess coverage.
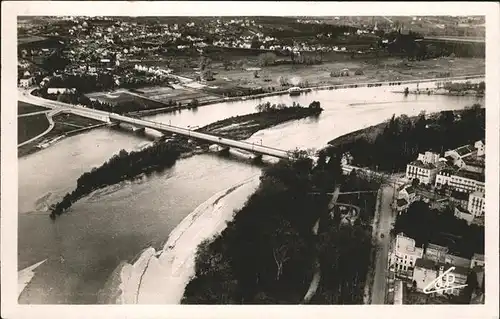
[412,258,469,296]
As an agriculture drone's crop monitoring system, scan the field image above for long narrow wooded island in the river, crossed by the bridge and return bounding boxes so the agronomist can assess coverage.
[50,101,322,220]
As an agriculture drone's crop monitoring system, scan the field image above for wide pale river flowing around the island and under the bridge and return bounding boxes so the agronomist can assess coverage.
[18,83,484,304]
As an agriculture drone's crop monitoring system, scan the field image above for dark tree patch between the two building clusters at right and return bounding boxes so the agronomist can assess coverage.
[392,201,485,259]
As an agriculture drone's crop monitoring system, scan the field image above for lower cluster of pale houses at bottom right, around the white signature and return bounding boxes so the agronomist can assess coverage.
[389,233,485,298]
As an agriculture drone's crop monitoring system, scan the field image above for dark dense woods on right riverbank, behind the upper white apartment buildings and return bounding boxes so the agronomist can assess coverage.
[330,104,486,172]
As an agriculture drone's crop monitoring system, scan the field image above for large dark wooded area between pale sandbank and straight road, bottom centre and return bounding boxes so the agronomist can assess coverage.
[182,152,371,304]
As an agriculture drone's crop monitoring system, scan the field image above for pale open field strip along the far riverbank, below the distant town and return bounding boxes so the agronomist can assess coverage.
[188,58,485,94]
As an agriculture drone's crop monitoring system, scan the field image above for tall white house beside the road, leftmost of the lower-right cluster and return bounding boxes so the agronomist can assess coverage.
[390,233,424,278]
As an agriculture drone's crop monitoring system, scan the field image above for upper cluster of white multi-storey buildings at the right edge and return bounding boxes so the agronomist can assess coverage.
[394,140,485,224]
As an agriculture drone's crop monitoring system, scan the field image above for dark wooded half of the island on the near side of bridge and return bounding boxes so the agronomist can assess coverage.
[50,142,188,219]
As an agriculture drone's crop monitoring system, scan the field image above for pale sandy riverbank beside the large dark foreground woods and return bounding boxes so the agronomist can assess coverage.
[98,176,260,304]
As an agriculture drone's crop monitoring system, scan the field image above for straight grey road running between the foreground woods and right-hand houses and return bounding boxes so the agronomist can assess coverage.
[371,185,395,305]
